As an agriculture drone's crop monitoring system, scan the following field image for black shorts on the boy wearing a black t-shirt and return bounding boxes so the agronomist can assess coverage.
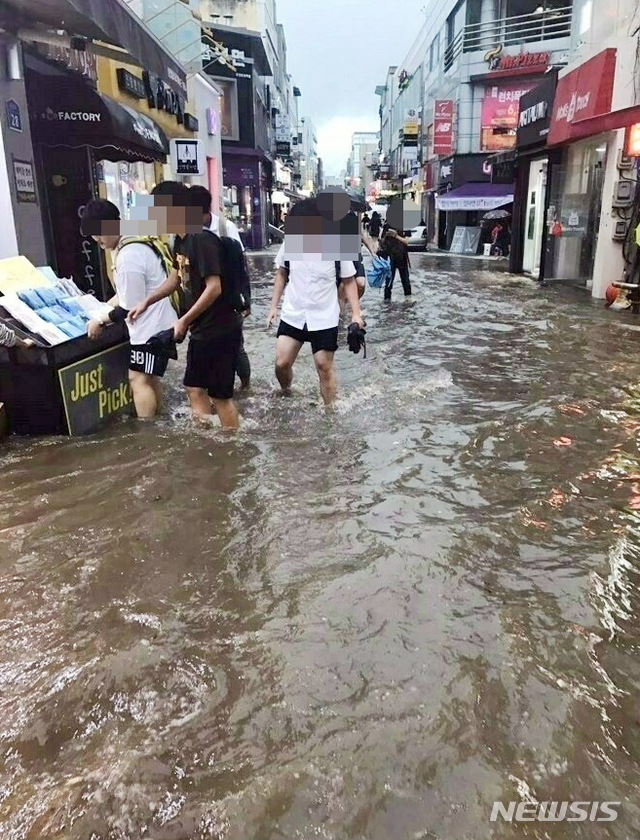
[184,328,242,400]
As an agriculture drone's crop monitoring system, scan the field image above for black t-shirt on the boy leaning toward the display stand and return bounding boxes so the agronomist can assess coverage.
[178,230,242,340]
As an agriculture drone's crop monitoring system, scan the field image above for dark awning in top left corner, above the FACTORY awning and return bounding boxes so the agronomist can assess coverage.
[0,0,187,96]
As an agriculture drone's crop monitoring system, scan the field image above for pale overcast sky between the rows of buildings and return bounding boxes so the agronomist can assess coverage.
[276,0,426,175]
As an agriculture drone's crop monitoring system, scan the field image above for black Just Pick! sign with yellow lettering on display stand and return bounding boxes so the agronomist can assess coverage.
[58,343,133,435]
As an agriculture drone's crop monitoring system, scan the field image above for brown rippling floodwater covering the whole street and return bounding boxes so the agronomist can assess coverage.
[0,255,640,840]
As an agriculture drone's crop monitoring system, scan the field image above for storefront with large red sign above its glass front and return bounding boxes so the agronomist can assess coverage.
[542,49,616,288]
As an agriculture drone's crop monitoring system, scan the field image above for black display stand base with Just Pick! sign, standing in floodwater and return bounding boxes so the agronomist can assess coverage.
[0,324,132,435]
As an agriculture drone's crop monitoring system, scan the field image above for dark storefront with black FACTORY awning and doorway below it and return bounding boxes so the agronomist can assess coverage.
[25,52,169,300]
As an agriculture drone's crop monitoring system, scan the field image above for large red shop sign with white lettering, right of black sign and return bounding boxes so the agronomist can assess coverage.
[547,48,616,146]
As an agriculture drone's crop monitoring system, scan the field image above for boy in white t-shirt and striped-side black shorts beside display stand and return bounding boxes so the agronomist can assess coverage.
[82,199,176,418]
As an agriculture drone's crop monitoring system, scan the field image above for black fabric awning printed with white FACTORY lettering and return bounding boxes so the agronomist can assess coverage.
[27,75,169,162]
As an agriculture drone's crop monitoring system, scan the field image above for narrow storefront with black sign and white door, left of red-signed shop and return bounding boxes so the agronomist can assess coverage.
[508,73,557,278]
